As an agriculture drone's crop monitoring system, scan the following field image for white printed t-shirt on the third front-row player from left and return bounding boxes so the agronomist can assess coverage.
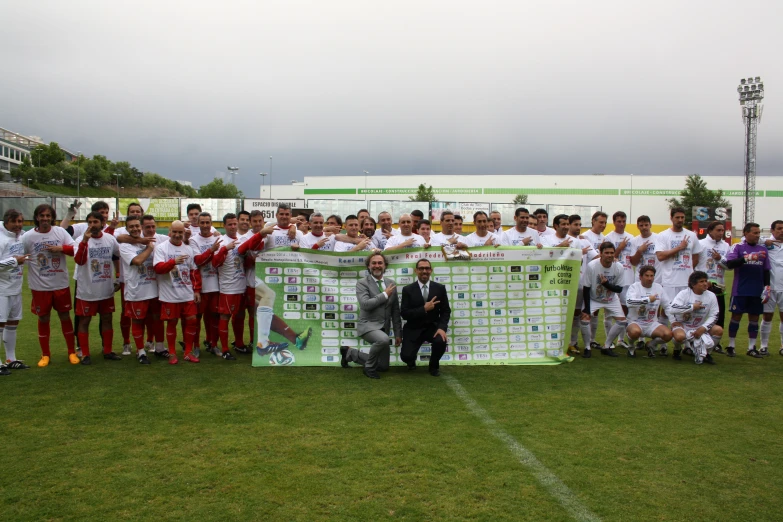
[73,233,120,301]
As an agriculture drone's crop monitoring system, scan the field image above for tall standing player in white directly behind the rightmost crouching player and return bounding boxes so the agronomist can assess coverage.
[655,207,703,359]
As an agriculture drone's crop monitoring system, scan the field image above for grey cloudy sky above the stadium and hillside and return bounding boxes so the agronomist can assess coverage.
[0,0,783,194]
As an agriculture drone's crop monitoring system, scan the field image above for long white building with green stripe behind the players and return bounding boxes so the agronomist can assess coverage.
[261,174,783,228]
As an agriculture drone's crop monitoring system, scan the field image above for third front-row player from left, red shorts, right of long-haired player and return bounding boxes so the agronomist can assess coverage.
[74,212,122,364]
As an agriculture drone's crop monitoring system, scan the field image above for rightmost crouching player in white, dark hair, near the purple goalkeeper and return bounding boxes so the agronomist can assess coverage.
[666,271,723,364]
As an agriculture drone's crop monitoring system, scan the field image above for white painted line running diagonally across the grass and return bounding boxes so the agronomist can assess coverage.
[443,375,601,522]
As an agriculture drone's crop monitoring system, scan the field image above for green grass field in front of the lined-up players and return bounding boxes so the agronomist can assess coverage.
[0,262,783,521]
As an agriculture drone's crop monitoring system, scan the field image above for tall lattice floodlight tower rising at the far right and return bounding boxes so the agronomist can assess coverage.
[737,76,764,224]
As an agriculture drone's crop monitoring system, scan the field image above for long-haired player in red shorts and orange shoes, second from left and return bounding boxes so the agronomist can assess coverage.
[22,204,79,368]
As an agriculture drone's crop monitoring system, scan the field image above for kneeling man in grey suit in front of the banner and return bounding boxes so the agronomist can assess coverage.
[340,250,402,379]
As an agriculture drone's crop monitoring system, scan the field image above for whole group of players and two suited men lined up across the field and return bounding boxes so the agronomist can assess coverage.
[0,198,783,378]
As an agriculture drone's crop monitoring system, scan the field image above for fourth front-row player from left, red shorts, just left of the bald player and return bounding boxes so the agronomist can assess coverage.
[120,216,160,364]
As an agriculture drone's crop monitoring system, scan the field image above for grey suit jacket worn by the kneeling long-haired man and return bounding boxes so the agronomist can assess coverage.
[356,274,402,337]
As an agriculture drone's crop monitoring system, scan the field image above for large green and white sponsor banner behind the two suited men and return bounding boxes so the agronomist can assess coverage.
[253,247,582,366]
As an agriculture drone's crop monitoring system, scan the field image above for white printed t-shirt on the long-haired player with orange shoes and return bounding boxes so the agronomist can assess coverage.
[22,227,73,292]
